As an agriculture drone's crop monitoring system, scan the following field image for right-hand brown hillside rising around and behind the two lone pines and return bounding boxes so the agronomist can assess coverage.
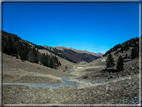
[71,38,139,80]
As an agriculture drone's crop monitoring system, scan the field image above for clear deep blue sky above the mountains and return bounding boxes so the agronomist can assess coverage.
[2,3,139,53]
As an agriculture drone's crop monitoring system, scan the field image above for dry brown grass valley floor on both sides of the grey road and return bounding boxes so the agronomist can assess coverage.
[2,54,140,105]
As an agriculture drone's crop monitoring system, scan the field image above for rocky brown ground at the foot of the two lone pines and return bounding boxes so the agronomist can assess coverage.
[78,58,139,83]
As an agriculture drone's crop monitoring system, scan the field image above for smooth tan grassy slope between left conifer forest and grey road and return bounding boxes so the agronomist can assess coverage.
[2,54,72,84]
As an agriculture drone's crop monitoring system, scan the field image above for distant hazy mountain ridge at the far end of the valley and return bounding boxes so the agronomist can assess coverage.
[38,45,103,63]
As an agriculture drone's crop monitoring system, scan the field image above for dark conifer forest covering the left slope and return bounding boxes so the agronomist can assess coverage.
[2,31,61,69]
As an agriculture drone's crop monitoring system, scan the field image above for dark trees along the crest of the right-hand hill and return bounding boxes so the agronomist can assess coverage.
[103,37,139,56]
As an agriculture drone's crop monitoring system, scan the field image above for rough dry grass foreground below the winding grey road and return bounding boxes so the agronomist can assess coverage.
[3,75,139,104]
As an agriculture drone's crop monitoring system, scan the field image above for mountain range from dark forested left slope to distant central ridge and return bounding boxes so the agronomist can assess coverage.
[2,31,103,69]
